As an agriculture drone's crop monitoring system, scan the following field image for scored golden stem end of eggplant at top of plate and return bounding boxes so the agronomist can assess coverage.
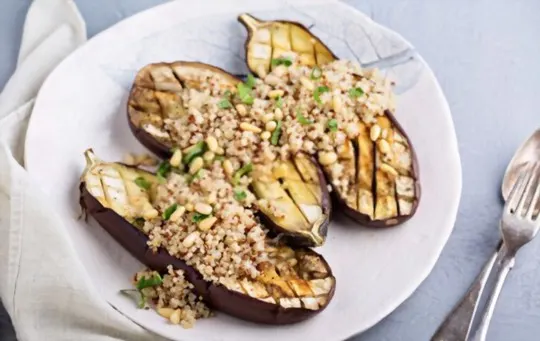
[238,13,338,77]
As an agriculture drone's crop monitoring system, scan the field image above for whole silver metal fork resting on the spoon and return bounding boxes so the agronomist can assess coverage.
[471,162,540,341]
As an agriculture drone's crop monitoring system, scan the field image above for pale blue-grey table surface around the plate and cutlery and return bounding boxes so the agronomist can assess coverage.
[0,0,540,341]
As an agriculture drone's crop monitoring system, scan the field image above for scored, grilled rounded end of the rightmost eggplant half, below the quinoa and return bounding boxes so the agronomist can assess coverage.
[325,110,420,227]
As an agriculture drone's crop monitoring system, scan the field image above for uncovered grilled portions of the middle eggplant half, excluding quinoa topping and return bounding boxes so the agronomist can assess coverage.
[128,62,332,247]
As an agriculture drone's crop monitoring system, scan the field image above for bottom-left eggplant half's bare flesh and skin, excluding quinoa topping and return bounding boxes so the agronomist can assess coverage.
[80,150,335,324]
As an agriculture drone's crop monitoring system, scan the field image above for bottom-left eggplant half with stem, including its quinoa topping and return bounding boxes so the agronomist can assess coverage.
[80,150,335,324]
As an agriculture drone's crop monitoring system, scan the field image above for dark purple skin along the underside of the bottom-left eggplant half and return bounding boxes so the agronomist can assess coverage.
[79,183,335,325]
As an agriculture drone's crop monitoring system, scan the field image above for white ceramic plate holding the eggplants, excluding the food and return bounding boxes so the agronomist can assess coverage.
[26,0,461,341]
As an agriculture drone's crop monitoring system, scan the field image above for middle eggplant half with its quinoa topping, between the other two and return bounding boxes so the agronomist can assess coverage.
[128,62,331,247]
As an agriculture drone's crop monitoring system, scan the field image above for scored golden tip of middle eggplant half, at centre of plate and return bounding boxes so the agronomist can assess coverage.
[251,153,331,247]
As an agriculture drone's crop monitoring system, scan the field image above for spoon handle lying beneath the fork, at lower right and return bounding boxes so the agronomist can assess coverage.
[431,243,501,341]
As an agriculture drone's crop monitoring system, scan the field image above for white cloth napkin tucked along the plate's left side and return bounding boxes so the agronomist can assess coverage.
[0,0,166,341]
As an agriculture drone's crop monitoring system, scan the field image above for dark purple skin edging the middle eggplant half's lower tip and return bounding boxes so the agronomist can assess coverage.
[257,153,333,248]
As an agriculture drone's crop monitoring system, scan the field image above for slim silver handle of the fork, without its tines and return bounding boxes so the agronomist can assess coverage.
[471,246,515,341]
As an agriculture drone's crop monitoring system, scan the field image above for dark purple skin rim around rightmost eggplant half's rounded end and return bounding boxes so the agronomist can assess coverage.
[328,110,422,228]
